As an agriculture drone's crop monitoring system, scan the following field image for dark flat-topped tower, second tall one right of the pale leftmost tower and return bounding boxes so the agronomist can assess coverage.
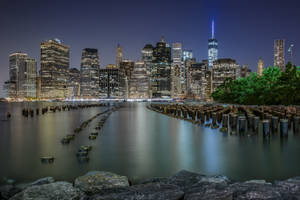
[80,48,100,98]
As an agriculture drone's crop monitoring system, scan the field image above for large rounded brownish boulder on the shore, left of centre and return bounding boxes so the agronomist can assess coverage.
[75,171,129,195]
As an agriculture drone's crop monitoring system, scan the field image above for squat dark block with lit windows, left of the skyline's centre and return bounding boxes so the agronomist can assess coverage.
[99,68,126,99]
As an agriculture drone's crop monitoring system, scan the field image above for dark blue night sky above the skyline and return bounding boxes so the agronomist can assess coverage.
[0,0,300,96]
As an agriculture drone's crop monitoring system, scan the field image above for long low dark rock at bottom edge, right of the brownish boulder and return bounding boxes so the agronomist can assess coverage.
[89,183,184,200]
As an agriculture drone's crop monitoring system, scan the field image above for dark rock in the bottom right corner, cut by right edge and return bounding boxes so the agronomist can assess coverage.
[275,177,300,200]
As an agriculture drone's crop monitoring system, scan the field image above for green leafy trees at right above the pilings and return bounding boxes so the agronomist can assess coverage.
[212,63,300,105]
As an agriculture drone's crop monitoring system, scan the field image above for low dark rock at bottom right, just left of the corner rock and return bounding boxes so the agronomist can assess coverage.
[229,183,283,200]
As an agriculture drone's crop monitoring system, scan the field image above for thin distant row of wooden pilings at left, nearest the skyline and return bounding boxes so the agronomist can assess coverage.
[22,103,108,117]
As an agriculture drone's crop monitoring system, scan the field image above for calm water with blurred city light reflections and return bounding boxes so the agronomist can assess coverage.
[0,103,300,182]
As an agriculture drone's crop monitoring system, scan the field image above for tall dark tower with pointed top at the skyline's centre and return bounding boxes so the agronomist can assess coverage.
[151,37,171,98]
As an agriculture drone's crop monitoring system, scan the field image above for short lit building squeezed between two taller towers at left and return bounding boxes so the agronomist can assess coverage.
[69,68,80,98]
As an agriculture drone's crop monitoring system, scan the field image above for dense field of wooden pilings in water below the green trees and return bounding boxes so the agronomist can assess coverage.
[149,104,300,137]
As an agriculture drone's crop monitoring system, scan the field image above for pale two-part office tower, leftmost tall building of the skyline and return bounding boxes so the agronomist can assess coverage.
[9,52,37,98]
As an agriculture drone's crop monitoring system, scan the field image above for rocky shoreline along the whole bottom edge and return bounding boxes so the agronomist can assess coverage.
[0,170,300,200]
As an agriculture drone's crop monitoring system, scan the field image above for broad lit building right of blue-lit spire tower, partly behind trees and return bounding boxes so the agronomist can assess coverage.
[212,58,241,91]
